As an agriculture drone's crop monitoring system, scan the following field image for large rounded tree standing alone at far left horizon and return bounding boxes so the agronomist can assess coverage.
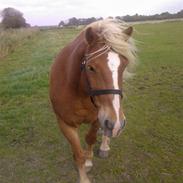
[1,8,27,29]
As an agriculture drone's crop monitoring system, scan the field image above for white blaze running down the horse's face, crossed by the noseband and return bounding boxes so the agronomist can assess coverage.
[108,52,120,135]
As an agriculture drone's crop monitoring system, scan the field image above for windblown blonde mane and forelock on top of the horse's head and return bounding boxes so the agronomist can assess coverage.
[86,19,137,79]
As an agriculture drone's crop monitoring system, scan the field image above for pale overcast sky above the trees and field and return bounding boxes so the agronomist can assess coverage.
[0,0,183,26]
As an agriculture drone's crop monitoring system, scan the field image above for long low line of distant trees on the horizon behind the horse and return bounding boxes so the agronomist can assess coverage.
[58,10,183,27]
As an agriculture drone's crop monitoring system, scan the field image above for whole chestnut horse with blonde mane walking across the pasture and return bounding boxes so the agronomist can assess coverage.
[50,19,136,183]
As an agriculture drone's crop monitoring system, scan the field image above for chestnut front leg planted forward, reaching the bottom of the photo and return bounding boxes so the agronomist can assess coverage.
[59,120,90,183]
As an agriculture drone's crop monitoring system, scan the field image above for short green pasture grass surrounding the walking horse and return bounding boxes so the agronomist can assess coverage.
[0,22,183,183]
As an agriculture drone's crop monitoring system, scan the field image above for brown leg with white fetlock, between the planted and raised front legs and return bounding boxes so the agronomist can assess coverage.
[85,121,99,172]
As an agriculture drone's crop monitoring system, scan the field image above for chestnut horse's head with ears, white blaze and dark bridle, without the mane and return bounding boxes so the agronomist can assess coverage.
[83,27,133,137]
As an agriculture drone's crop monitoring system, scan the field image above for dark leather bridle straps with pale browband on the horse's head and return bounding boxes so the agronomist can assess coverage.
[81,45,123,106]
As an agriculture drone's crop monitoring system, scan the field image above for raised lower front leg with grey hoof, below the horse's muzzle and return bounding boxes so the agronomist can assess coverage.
[99,135,110,158]
